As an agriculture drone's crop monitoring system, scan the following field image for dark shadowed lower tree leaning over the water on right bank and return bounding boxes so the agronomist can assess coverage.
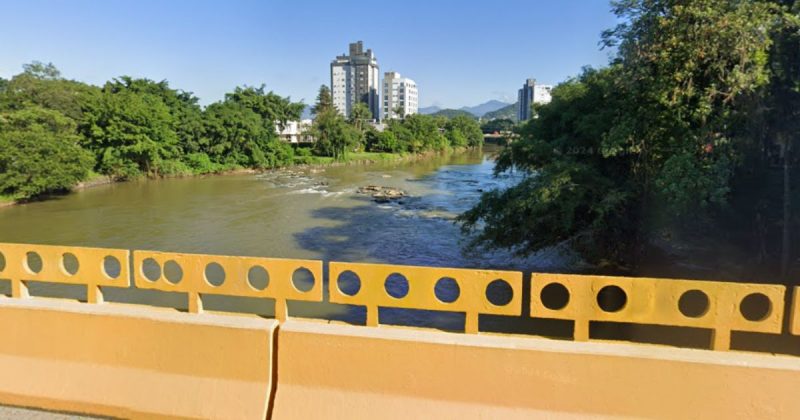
[458,67,637,264]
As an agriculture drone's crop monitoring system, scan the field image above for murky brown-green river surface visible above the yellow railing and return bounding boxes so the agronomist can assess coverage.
[0,148,566,270]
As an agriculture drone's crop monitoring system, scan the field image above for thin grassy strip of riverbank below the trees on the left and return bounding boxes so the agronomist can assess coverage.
[0,147,470,209]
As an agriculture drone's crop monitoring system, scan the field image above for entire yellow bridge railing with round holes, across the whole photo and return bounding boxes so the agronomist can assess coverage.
[0,243,800,350]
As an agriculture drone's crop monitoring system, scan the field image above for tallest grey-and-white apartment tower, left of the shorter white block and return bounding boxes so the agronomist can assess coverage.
[331,41,380,120]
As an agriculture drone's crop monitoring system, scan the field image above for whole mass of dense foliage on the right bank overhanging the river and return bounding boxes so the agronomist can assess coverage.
[460,0,800,274]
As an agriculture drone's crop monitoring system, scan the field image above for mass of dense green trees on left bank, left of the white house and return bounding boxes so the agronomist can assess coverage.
[0,62,304,199]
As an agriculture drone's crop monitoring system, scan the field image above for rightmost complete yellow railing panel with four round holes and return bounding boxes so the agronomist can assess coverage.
[531,274,786,350]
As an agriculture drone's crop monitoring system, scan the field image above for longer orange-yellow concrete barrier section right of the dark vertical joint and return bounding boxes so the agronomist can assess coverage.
[273,320,800,419]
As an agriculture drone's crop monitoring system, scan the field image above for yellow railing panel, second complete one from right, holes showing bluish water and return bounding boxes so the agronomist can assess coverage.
[329,262,522,333]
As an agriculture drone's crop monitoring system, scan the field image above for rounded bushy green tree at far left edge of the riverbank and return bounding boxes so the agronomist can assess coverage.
[0,106,94,199]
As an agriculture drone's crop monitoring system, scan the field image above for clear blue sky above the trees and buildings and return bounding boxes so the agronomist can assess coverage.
[0,0,616,107]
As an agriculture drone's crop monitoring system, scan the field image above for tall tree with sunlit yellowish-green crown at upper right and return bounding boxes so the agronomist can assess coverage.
[604,0,777,215]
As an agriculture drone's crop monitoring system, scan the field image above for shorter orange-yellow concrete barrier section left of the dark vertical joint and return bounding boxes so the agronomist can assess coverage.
[0,296,277,419]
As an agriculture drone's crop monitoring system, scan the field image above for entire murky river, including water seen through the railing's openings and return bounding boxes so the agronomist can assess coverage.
[0,150,800,352]
